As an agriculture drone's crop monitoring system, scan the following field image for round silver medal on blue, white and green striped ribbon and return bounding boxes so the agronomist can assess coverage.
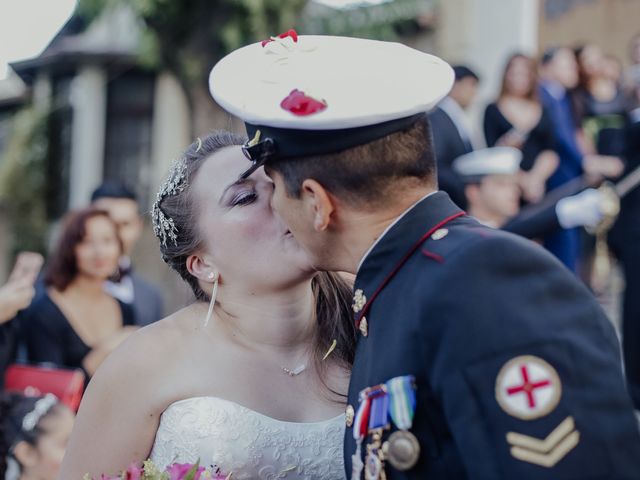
[383,375,420,471]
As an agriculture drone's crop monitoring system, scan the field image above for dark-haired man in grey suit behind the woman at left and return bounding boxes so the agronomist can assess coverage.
[91,181,164,326]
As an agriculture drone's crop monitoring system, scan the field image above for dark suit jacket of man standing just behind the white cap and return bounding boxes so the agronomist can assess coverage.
[428,107,473,208]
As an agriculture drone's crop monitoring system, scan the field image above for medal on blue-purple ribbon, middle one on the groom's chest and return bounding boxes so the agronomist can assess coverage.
[364,384,389,480]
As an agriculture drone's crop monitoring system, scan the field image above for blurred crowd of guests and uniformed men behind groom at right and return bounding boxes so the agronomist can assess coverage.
[429,34,640,416]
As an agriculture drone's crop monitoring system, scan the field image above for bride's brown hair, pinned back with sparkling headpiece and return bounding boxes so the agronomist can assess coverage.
[153,130,356,372]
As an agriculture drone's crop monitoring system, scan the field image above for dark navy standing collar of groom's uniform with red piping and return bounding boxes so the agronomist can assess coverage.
[354,191,462,306]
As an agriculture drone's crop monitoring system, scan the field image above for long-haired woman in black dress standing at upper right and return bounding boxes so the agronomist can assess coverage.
[484,53,558,203]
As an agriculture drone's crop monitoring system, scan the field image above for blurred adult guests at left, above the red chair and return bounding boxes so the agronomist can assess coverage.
[0,182,163,381]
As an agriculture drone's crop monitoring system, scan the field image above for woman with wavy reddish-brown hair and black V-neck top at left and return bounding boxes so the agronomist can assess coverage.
[24,210,135,377]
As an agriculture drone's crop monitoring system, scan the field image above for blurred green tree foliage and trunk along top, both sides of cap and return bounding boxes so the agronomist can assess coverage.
[78,0,433,136]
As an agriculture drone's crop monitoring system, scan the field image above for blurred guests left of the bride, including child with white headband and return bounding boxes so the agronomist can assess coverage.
[0,182,164,479]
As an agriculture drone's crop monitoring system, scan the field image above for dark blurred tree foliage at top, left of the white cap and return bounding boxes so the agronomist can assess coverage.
[78,0,306,108]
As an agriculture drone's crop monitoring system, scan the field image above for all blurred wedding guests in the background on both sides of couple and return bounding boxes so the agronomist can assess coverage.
[0,34,640,479]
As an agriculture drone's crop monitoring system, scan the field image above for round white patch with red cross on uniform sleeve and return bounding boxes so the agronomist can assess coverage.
[496,355,562,420]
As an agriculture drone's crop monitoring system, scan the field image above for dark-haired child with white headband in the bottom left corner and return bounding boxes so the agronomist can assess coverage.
[0,393,73,480]
